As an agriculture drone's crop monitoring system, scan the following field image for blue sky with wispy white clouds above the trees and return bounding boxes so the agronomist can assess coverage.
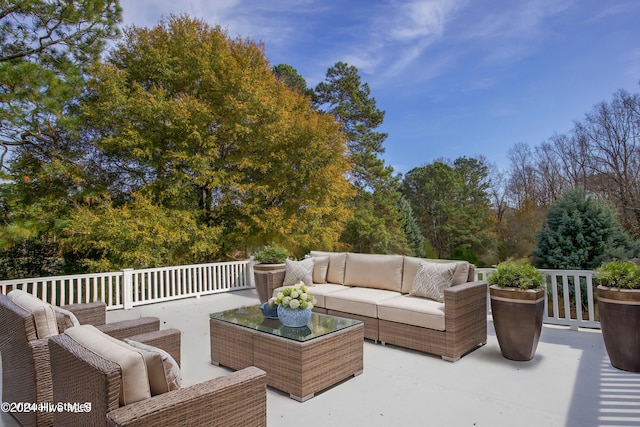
[120,0,640,173]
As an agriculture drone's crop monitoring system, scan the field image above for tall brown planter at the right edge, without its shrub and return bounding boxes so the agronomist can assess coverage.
[597,285,640,372]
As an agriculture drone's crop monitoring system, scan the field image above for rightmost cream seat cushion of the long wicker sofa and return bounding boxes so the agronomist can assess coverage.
[378,295,445,331]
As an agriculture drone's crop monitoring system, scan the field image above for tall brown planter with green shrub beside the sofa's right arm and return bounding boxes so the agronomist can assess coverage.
[487,261,545,361]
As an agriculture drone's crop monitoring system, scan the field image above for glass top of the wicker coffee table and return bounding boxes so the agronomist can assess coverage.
[209,305,362,342]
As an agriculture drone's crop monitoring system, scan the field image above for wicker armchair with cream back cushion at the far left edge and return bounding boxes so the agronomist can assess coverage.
[0,290,162,426]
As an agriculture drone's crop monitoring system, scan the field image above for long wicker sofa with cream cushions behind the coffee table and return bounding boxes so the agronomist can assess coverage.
[272,251,487,362]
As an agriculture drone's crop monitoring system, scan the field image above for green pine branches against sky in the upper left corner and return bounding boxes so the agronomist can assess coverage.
[0,0,121,172]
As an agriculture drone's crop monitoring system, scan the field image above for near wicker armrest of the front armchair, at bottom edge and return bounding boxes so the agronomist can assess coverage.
[107,366,267,426]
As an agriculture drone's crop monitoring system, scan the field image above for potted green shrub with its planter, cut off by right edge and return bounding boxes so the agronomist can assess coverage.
[594,260,640,372]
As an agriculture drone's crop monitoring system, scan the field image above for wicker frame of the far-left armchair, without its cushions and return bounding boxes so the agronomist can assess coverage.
[0,294,165,426]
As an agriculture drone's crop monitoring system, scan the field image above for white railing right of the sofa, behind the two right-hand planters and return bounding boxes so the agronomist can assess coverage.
[476,268,600,329]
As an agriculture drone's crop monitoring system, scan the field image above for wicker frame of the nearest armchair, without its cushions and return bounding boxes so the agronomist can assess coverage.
[49,334,267,427]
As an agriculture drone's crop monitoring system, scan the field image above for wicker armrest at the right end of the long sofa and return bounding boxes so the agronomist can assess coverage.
[444,281,488,331]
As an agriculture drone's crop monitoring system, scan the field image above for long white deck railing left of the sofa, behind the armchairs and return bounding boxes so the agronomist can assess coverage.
[0,260,254,310]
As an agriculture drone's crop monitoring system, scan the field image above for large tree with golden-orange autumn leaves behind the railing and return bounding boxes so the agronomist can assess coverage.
[81,16,352,257]
